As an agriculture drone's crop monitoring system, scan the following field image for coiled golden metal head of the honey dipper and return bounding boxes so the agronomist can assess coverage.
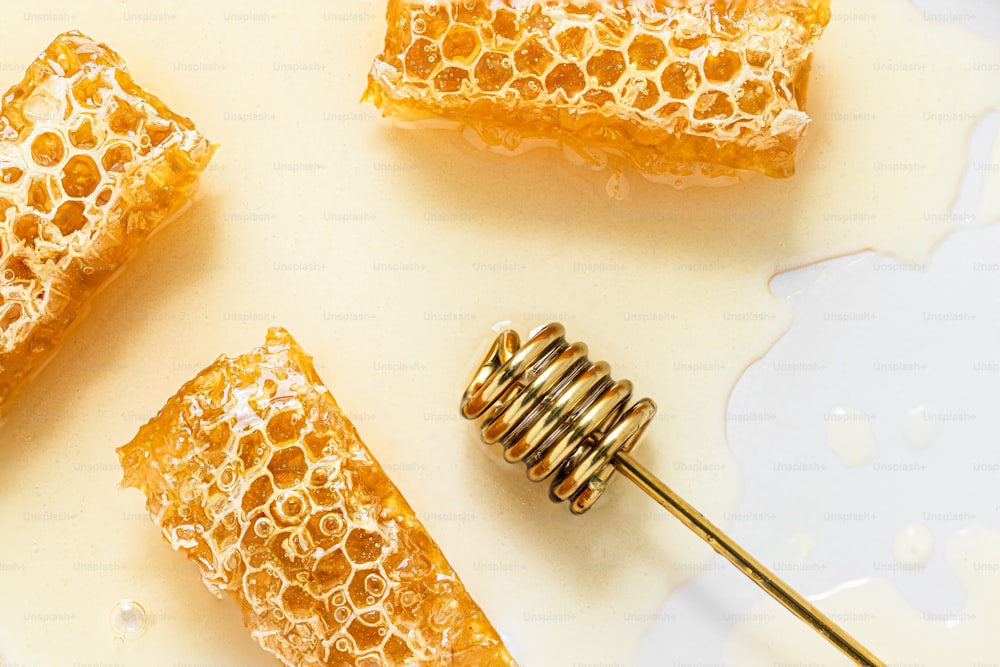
[462,324,656,514]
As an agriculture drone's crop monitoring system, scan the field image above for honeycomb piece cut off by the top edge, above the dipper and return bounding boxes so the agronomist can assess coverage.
[364,0,830,185]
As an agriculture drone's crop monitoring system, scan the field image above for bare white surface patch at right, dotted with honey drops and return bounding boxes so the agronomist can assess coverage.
[704,146,1000,667]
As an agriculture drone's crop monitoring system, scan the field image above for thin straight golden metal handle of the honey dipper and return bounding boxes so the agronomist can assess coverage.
[613,452,885,667]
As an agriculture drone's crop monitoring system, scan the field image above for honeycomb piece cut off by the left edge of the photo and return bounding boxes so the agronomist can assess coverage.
[0,32,214,411]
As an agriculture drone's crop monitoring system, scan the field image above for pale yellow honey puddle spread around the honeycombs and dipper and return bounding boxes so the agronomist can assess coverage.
[0,0,1000,667]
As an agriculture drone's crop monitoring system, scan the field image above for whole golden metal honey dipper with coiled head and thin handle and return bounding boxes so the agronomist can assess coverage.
[461,323,885,667]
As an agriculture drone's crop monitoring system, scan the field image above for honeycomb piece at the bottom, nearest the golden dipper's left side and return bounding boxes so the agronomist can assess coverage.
[118,328,516,667]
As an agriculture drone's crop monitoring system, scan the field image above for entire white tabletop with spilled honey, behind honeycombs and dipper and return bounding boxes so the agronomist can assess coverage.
[0,0,1000,667]
